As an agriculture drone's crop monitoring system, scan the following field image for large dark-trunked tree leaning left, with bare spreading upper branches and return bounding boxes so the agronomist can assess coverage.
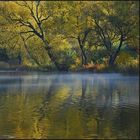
[3,1,65,70]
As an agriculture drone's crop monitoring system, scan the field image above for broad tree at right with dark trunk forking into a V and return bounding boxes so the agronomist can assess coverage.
[90,2,138,66]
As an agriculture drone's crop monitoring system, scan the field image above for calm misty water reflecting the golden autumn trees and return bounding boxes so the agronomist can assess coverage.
[0,72,139,139]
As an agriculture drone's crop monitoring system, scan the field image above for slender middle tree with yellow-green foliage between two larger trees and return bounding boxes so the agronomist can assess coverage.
[55,1,91,65]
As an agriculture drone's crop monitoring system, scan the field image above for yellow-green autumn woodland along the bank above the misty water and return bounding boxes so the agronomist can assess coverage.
[0,1,139,73]
